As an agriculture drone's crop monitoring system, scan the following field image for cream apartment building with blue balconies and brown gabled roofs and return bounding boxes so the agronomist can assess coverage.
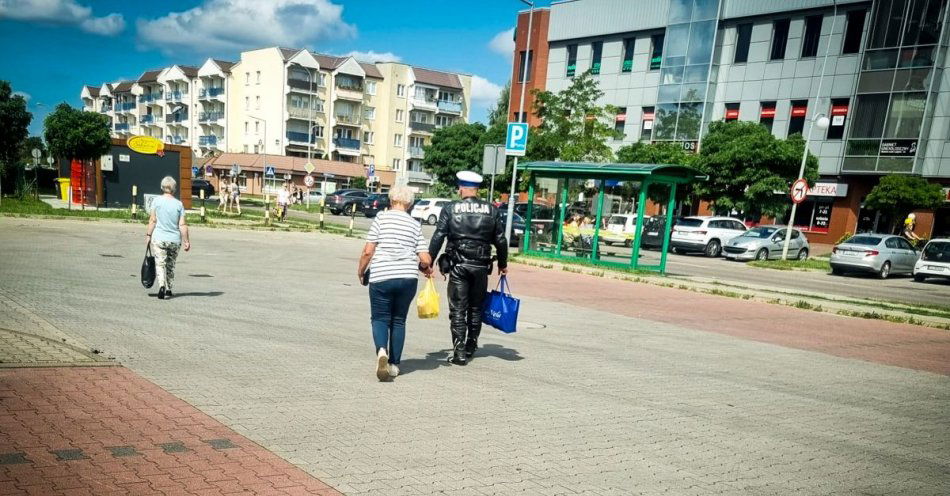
[82,47,471,189]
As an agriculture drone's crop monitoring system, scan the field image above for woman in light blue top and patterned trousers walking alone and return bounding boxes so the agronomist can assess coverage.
[145,176,191,300]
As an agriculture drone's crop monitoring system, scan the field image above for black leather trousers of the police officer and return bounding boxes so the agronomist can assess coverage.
[448,265,491,348]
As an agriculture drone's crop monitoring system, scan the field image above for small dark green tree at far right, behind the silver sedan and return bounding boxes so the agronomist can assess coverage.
[864,175,944,232]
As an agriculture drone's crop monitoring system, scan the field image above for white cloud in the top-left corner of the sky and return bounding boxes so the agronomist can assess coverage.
[0,0,125,36]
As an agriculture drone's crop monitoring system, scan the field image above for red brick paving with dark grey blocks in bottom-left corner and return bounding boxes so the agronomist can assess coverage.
[0,367,340,496]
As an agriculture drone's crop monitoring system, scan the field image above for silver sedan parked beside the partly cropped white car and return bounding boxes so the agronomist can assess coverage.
[831,234,917,279]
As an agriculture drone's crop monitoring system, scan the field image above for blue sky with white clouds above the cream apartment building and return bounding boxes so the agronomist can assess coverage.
[0,0,550,134]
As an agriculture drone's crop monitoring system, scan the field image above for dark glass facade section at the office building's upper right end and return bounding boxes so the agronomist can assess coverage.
[842,0,947,173]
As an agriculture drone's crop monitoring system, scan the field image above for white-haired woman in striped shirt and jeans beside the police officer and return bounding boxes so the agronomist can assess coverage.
[356,186,432,381]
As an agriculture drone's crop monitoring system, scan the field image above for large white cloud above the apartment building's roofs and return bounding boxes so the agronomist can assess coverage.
[142,0,356,53]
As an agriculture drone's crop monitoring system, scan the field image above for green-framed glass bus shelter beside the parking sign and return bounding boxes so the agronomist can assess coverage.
[517,162,705,273]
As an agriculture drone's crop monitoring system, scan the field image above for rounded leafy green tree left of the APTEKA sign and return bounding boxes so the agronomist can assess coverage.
[692,121,818,218]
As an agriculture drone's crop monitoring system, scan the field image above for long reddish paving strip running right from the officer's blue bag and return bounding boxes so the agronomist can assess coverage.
[512,265,950,375]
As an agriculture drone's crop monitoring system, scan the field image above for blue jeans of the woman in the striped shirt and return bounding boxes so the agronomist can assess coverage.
[369,278,419,365]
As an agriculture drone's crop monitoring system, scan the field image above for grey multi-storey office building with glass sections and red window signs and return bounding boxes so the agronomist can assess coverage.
[512,0,950,243]
